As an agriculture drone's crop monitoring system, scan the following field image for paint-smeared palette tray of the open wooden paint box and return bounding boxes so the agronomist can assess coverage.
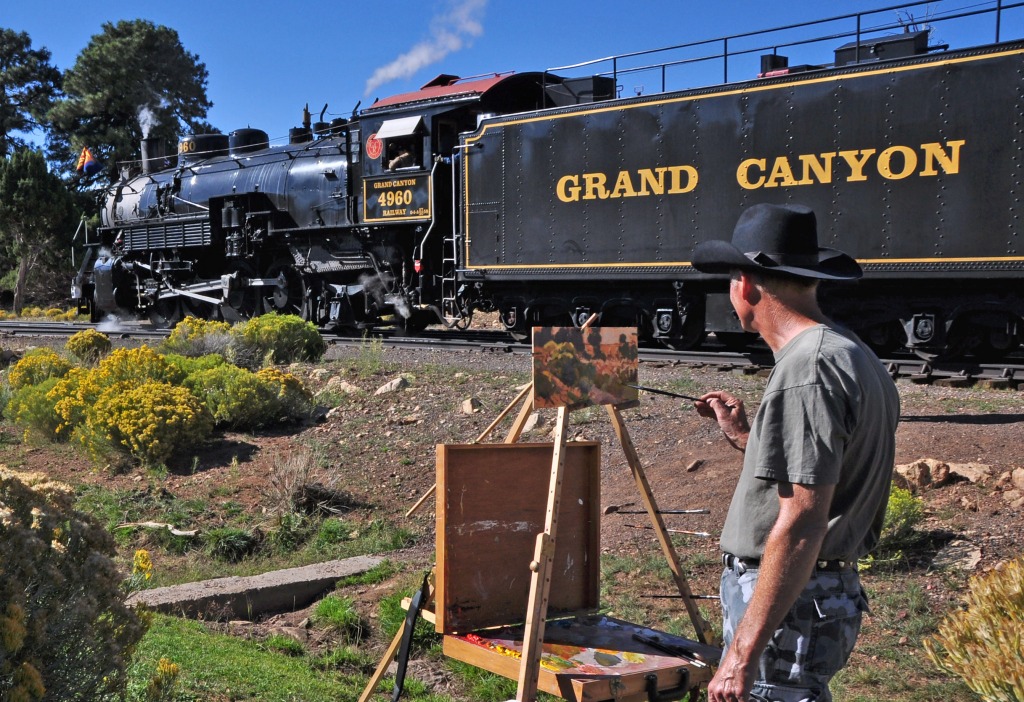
[443,615,711,702]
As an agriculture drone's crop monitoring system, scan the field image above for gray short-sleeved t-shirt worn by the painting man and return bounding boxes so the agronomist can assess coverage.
[721,325,899,561]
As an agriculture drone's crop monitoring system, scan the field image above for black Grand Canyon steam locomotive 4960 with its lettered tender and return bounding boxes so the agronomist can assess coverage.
[73,2,1024,357]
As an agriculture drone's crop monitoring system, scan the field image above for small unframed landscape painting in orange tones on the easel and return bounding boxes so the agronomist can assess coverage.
[534,326,638,409]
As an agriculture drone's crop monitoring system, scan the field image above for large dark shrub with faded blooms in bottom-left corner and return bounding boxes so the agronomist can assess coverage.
[0,467,148,702]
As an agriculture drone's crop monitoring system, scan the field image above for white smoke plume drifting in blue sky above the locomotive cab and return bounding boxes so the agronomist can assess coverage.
[366,0,487,95]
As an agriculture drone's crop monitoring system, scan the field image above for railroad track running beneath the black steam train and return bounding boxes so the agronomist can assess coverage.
[0,321,1024,389]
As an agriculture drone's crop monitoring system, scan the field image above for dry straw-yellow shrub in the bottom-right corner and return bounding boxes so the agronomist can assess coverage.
[924,557,1024,702]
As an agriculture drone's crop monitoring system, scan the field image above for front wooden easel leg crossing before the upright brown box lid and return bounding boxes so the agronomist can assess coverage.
[515,407,568,702]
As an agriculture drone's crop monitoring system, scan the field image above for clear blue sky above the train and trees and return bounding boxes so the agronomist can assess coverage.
[0,0,1024,145]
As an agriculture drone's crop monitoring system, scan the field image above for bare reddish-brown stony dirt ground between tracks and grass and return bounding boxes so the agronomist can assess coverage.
[0,333,1024,699]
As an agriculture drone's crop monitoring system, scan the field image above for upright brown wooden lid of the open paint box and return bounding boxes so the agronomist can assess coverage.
[435,441,601,633]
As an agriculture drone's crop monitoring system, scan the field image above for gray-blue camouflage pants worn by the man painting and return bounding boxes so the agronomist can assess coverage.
[721,563,867,702]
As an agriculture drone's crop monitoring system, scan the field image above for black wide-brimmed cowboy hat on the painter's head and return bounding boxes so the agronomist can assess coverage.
[693,204,863,280]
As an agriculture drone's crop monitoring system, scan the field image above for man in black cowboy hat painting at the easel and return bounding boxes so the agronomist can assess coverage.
[693,205,899,702]
